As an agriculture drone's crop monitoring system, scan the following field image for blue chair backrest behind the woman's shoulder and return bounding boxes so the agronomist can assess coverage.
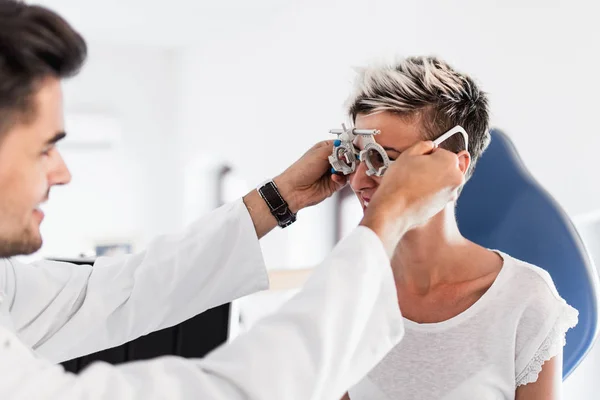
[457,130,599,378]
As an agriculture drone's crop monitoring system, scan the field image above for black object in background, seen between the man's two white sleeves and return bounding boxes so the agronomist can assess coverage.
[55,259,231,372]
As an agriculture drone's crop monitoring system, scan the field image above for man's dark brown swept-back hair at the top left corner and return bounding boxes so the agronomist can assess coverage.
[0,0,87,139]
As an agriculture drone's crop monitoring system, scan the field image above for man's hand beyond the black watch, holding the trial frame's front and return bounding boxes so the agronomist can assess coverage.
[274,140,346,213]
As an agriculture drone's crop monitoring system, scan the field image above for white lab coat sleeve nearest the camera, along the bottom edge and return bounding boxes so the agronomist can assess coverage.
[0,228,404,400]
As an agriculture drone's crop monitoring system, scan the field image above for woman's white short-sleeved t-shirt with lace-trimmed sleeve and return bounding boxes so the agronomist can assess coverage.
[349,252,578,400]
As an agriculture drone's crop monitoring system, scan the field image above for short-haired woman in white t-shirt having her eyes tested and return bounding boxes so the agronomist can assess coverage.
[344,58,577,400]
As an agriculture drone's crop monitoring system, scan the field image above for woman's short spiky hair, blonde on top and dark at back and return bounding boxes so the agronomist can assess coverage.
[348,57,490,178]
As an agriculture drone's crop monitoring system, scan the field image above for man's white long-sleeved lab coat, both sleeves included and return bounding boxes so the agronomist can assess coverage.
[0,200,403,400]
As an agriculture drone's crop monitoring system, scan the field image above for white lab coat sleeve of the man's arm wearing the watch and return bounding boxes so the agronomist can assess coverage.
[0,200,268,362]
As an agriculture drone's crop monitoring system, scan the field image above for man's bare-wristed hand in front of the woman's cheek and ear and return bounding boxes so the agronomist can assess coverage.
[361,141,465,256]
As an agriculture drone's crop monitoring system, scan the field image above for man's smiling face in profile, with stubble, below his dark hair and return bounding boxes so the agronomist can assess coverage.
[0,78,71,257]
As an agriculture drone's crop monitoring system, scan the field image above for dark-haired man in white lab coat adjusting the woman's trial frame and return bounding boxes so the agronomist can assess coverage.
[0,0,463,400]
